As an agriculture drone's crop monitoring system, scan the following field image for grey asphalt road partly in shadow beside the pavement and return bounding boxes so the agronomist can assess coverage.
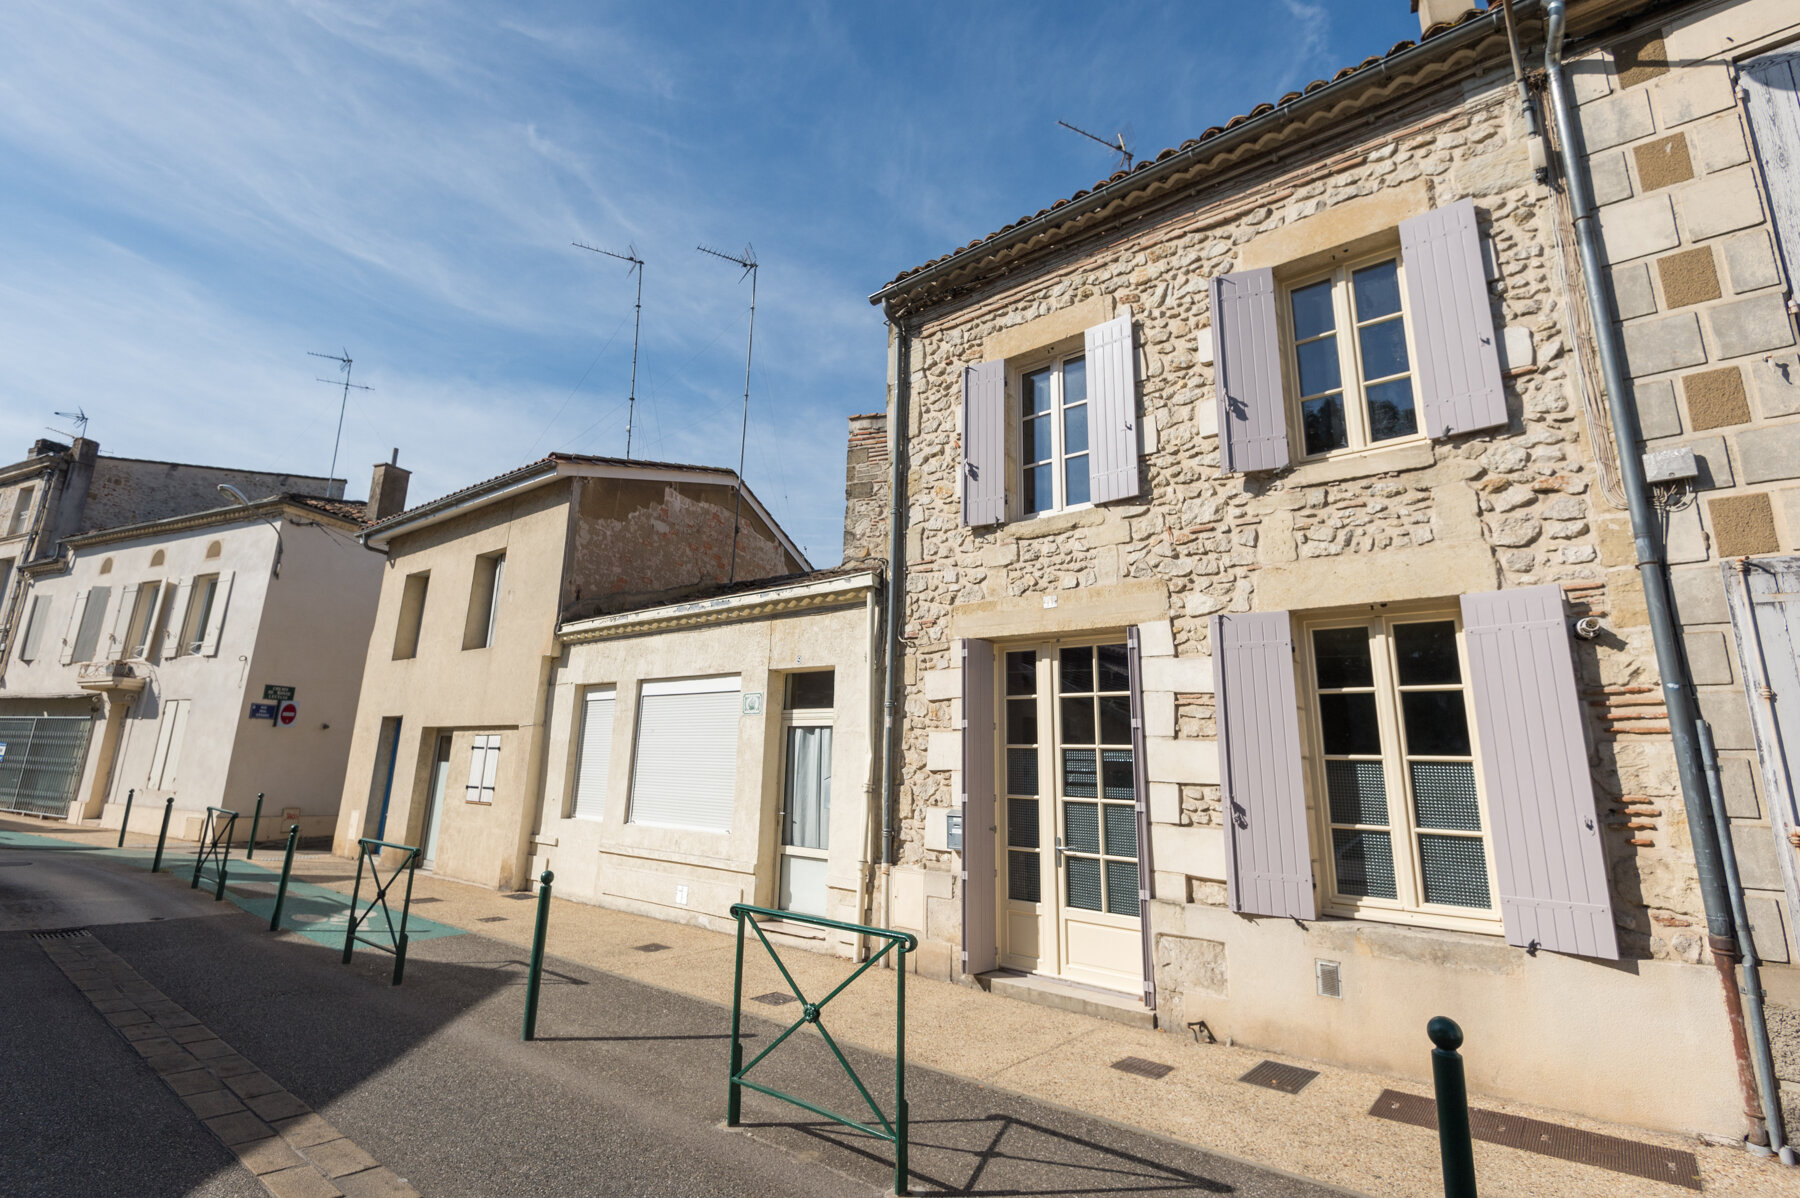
[0,849,1343,1198]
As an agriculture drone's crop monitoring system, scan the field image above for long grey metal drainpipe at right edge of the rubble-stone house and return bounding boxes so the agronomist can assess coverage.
[1544,0,1768,1146]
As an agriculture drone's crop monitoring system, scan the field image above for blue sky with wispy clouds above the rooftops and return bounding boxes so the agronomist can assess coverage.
[0,0,1418,565]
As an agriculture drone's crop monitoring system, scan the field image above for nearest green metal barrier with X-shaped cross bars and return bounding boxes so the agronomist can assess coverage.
[725,903,918,1194]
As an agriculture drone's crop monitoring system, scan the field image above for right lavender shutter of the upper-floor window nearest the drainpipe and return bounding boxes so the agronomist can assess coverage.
[1400,200,1507,439]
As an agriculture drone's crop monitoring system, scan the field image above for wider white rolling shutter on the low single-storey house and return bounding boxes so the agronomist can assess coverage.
[630,676,742,833]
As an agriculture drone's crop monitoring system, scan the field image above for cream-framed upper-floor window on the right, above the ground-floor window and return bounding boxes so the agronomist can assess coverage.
[1283,254,1420,457]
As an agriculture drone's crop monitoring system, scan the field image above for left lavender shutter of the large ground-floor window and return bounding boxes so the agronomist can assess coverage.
[1213,612,1318,919]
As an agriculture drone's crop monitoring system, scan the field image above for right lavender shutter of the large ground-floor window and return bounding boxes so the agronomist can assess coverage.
[1462,586,1618,961]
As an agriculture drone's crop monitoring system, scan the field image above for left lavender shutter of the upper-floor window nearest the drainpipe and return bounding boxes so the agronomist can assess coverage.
[1211,268,1289,471]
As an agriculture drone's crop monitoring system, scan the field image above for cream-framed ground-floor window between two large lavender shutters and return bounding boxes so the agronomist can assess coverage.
[1305,613,1499,930]
